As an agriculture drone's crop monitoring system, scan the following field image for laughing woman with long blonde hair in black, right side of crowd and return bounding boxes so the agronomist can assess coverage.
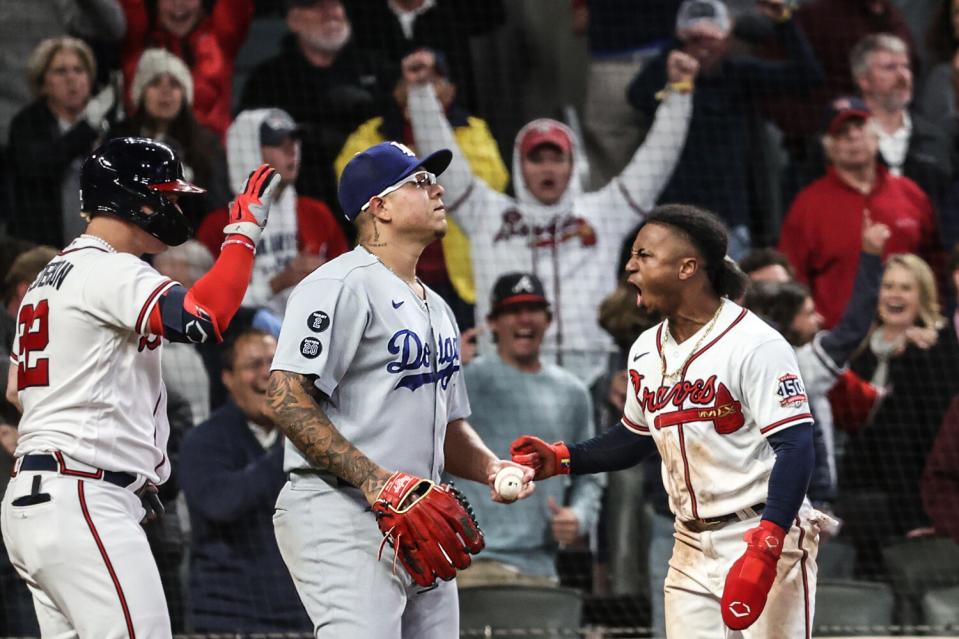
[837,254,959,575]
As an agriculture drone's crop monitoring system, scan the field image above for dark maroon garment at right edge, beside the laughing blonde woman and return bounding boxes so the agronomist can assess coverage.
[921,397,959,544]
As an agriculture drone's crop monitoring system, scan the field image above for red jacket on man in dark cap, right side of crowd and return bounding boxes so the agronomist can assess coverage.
[779,166,938,328]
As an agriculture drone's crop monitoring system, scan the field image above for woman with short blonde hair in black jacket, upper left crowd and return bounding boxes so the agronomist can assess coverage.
[9,37,106,247]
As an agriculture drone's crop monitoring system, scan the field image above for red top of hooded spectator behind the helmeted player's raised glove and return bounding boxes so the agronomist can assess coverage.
[196,195,349,261]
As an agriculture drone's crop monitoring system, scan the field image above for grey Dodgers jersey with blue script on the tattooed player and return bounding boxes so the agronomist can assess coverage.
[273,246,469,481]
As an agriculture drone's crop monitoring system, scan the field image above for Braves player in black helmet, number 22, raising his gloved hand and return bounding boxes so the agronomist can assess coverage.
[2,138,276,639]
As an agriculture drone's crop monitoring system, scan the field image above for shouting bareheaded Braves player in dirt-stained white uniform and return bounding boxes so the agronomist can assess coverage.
[512,205,824,639]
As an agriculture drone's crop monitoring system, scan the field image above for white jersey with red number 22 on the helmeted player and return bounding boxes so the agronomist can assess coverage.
[11,235,175,483]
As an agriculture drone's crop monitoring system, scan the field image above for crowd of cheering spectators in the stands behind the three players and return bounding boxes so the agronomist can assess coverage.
[0,0,959,635]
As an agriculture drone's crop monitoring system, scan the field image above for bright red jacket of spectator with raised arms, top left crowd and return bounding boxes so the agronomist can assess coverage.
[120,0,254,139]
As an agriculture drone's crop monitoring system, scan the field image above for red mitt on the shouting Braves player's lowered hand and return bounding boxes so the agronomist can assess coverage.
[722,519,786,630]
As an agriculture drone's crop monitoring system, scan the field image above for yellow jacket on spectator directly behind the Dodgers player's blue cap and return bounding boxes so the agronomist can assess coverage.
[334,116,509,304]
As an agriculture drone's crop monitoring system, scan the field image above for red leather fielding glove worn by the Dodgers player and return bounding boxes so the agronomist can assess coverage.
[373,472,486,588]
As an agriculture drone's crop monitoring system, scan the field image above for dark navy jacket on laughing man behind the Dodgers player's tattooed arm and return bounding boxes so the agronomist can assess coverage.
[174,401,311,633]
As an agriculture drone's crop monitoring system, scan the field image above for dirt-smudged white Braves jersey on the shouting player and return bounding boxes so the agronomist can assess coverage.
[623,300,812,521]
